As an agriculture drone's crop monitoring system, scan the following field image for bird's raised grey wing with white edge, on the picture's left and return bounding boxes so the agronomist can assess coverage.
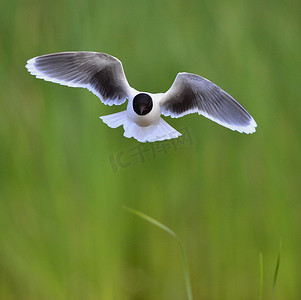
[26,51,132,105]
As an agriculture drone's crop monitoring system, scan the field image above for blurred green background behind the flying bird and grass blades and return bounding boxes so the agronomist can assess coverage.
[0,0,301,300]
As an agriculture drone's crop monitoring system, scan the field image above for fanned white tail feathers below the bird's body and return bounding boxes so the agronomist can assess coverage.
[100,111,181,143]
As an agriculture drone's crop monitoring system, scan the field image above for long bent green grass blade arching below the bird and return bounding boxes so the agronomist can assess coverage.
[123,206,193,300]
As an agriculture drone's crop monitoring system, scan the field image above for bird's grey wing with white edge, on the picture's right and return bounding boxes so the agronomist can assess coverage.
[161,73,257,133]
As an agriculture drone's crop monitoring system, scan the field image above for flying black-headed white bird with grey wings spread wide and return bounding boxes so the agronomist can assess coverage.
[26,51,257,142]
